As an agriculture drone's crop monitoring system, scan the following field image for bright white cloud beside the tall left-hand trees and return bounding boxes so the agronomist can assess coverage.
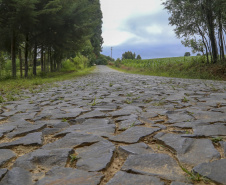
[100,0,163,46]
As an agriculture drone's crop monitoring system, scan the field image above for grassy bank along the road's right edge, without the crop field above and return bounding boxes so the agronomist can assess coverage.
[109,62,226,80]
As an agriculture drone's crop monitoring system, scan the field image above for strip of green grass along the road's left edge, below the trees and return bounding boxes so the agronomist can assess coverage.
[0,67,95,103]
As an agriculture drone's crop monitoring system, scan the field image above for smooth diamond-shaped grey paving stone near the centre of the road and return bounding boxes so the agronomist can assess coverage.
[110,126,160,143]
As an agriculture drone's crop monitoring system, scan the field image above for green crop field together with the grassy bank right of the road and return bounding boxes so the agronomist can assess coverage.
[109,57,226,80]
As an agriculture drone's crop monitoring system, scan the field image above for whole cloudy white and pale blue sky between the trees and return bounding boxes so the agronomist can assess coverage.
[100,0,191,59]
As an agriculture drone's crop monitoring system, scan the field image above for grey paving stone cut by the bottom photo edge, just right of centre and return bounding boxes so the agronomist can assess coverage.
[107,171,164,185]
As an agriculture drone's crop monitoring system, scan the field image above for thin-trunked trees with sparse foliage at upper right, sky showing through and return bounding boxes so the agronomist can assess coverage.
[163,0,226,63]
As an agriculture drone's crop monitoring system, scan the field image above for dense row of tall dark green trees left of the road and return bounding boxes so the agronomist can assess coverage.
[0,0,103,78]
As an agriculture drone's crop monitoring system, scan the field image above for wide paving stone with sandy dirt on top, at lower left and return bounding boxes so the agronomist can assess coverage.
[13,148,73,171]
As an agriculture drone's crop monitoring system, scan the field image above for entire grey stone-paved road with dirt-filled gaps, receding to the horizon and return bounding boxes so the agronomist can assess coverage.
[0,66,226,185]
